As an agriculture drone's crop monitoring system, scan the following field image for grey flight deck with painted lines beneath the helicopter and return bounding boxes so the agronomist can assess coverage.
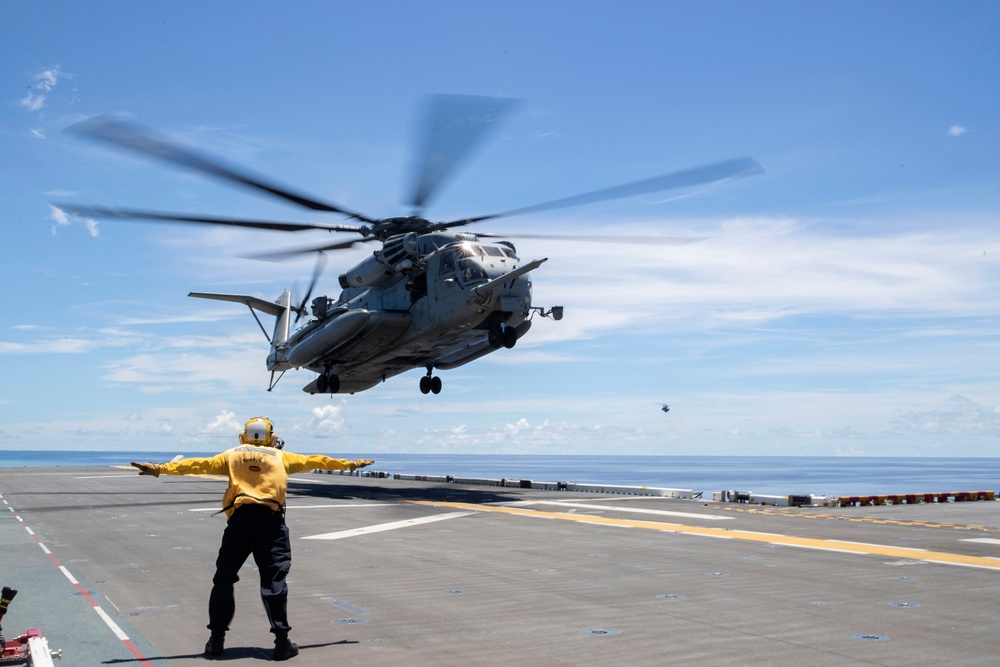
[0,467,1000,667]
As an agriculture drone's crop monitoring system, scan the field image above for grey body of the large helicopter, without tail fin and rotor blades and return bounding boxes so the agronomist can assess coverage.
[268,233,544,393]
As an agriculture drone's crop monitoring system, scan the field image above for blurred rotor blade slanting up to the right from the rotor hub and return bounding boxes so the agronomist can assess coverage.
[439,158,764,229]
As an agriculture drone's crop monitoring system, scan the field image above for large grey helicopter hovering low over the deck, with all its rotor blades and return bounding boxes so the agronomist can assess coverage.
[53,95,763,394]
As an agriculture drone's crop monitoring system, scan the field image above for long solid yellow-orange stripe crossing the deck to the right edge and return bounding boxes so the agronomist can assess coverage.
[409,500,1000,570]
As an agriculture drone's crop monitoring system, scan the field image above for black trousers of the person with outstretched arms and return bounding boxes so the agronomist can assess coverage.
[208,504,292,638]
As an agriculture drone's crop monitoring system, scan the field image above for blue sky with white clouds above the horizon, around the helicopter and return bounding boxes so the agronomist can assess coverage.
[0,1,1000,458]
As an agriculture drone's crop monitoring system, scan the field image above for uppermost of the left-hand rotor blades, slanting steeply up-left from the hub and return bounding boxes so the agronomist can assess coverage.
[67,115,376,222]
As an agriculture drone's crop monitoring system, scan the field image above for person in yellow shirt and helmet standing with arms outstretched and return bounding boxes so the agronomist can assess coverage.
[132,417,374,660]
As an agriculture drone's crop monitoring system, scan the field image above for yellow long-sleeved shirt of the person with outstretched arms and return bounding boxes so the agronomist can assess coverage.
[160,445,353,517]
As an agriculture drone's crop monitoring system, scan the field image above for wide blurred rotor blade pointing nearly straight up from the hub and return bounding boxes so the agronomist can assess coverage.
[409,95,518,211]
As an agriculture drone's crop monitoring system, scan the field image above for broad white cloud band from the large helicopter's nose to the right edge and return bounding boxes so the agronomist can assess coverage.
[518,218,1000,345]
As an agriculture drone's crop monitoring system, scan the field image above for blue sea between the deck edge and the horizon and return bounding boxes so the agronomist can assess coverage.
[0,449,1000,498]
